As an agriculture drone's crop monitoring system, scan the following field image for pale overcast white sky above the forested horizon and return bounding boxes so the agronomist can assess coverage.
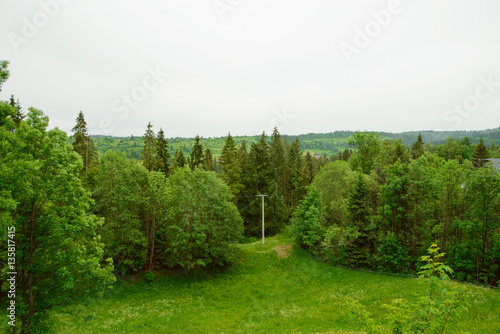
[0,0,500,137]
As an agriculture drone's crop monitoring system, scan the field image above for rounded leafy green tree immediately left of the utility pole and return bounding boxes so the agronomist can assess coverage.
[158,167,243,273]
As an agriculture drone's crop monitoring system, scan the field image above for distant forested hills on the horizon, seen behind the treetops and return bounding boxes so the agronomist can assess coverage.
[92,127,500,159]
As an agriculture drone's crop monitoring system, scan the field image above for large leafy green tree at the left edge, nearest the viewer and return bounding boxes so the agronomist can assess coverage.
[0,108,114,333]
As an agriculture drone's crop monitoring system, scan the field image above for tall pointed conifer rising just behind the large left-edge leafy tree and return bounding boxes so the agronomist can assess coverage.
[71,111,99,184]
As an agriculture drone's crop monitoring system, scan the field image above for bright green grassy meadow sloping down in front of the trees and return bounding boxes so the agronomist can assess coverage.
[52,235,500,333]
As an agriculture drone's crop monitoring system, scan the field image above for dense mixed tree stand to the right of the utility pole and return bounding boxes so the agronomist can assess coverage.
[291,132,500,285]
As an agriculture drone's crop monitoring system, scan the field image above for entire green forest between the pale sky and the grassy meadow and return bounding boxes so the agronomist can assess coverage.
[0,62,500,333]
